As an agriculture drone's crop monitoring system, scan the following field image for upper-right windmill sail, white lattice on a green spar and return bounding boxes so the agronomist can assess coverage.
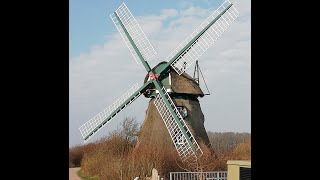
[166,0,239,75]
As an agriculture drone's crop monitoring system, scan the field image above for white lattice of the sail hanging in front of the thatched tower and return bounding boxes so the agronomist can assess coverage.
[154,87,203,161]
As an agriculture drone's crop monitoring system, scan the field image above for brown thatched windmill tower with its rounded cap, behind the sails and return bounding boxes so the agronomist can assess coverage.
[136,62,210,151]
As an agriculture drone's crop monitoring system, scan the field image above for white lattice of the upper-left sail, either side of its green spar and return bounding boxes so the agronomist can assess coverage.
[110,3,157,64]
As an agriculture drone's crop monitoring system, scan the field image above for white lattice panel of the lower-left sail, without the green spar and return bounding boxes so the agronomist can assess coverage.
[79,83,140,141]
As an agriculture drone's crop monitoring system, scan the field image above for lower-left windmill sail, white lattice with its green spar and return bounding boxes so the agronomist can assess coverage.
[79,83,150,141]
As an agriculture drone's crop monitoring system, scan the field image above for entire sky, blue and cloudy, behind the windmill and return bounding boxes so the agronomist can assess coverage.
[69,0,251,147]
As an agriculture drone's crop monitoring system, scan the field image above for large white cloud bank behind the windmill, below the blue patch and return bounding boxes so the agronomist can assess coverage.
[69,0,251,145]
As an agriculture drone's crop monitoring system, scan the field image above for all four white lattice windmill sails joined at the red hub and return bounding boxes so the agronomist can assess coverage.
[79,0,239,161]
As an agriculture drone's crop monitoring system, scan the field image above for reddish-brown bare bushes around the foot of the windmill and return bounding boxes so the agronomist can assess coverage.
[69,118,251,180]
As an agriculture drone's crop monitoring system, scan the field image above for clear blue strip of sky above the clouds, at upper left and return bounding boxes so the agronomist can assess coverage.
[69,0,223,57]
